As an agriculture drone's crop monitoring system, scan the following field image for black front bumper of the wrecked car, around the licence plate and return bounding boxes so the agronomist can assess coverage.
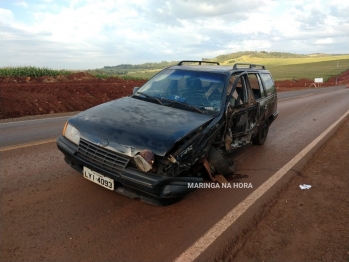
[57,136,203,202]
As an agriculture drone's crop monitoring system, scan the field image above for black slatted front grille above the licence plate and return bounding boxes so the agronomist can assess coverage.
[78,138,130,170]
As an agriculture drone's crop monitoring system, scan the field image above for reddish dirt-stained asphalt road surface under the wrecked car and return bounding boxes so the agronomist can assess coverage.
[0,86,349,261]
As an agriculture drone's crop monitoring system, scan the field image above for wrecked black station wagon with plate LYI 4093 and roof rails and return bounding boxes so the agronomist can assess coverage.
[57,61,278,204]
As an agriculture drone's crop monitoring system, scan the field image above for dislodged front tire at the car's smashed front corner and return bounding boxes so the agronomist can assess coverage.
[207,147,235,176]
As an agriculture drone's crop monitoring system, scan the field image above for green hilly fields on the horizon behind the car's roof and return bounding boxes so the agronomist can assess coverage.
[98,51,349,81]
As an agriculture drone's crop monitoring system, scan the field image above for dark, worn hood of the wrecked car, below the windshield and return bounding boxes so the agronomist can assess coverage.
[69,97,213,157]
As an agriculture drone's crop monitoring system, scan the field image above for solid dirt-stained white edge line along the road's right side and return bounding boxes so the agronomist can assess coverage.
[175,110,349,262]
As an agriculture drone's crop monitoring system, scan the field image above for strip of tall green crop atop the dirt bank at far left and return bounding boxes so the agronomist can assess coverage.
[0,66,73,78]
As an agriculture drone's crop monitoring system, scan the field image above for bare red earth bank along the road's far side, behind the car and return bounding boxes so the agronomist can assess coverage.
[0,70,349,119]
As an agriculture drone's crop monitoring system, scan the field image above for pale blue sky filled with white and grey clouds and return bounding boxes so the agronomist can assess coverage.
[0,0,349,69]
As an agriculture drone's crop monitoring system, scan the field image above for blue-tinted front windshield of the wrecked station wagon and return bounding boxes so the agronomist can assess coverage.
[133,69,226,113]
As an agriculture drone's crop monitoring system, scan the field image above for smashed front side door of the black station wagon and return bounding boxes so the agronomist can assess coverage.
[225,73,259,151]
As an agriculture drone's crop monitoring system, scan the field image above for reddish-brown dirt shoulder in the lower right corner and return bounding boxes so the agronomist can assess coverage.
[220,118,349,261]
